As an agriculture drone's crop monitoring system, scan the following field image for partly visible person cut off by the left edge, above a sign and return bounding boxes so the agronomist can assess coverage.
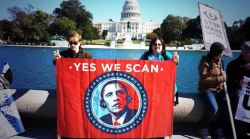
[0,59,12,90]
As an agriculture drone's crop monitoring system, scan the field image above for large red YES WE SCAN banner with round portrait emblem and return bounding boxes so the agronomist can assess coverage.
[56,58,176,138]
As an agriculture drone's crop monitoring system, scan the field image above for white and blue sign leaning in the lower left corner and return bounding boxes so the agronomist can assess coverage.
[0,89,25,139]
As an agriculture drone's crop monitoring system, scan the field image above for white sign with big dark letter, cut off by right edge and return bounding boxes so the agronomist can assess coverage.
[235,77,250,123]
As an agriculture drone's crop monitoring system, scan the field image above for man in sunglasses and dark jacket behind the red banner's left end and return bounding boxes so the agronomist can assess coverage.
[54,31,92,63]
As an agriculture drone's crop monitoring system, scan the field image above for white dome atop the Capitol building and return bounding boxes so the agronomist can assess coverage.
[121,0,141,21]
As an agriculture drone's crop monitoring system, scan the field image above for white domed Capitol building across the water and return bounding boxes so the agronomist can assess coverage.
[94,0,160,40]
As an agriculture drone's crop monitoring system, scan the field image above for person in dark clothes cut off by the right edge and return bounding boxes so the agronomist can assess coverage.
[226,41,250,139]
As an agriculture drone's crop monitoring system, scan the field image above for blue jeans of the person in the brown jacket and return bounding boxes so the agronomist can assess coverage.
[200,91,228,128]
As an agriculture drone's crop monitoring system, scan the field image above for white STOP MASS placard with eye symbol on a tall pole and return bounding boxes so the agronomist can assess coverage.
[198,2,232,56]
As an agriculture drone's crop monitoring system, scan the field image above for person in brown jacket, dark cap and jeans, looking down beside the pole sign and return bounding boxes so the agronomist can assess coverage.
[198,42,227,139]
